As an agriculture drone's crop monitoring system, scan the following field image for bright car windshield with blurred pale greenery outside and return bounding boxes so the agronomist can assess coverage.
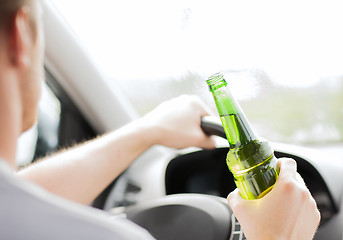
[54,0,343,144]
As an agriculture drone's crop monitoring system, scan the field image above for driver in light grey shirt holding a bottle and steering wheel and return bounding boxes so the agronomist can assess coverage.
[0,0,319,239]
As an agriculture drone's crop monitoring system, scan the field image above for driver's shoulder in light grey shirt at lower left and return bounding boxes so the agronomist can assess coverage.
[0,173,152,239]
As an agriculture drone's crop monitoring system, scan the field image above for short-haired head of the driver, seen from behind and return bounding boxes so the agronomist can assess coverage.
[0,0,44,131]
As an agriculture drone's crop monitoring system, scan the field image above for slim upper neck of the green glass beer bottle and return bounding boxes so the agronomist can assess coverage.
[207,75,256,148]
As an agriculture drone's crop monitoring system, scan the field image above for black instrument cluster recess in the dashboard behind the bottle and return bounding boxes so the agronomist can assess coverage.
[165,148,337,224]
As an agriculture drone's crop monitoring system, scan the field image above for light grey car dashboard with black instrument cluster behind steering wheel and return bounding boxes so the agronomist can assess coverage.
[105,139,343,240]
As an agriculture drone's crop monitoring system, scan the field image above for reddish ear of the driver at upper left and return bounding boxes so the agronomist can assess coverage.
[9,7,32,68]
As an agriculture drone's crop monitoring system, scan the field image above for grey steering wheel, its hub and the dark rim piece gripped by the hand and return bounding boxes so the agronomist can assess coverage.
[118,117,245,240]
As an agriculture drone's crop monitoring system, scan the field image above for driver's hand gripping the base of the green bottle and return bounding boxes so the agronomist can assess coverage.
[228,158,320,240]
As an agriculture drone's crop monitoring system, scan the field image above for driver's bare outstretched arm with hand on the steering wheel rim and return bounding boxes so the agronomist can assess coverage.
[17,96,215,204]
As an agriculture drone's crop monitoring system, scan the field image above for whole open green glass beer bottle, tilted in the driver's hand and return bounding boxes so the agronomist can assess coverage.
[207,73,278,199]
